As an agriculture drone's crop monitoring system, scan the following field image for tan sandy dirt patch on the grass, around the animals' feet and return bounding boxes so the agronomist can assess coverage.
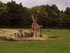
[0,30,63,41]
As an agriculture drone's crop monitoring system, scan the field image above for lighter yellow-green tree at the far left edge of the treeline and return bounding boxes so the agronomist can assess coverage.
[0,1,7,26]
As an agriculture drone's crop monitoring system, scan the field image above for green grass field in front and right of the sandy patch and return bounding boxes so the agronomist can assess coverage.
[0,29,70,53]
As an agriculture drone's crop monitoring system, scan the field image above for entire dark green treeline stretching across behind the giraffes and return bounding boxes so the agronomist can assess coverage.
[0,1,70,29]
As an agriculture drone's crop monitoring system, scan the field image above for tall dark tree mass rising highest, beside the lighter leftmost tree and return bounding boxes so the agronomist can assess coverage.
[7,1,28,27]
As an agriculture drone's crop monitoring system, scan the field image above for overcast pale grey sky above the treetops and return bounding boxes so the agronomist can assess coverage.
[0,0,70,10]
